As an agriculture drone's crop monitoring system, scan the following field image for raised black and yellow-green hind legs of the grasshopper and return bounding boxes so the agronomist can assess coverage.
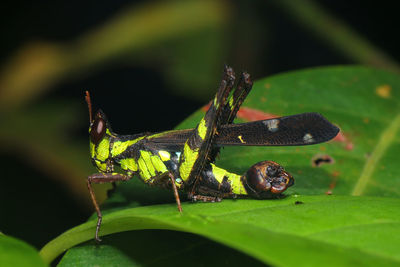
[179,66,252,199]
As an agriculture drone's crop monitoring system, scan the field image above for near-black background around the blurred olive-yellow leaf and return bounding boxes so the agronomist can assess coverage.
[0,0,400,251]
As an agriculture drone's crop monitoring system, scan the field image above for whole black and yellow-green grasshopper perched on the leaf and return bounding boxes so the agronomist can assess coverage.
[86,66,339,241]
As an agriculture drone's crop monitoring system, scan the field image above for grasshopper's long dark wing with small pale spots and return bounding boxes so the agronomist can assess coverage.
[149,113,339,150]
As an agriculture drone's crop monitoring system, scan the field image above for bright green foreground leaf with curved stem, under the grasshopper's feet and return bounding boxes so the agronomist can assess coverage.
[41,196,400,266]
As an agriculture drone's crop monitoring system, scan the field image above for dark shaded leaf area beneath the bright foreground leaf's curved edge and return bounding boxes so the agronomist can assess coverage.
[58,230,264,267]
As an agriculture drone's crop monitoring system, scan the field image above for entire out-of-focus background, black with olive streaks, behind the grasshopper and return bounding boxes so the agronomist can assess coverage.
[0,0,400,260]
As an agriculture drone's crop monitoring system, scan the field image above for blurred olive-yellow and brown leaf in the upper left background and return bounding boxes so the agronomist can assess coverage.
[0,1,229,110]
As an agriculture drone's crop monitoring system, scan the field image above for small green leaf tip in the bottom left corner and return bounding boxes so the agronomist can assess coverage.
[0,236,47,267]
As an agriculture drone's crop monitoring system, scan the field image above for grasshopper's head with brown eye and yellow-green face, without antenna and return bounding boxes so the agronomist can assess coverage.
[89,110,115,172]
